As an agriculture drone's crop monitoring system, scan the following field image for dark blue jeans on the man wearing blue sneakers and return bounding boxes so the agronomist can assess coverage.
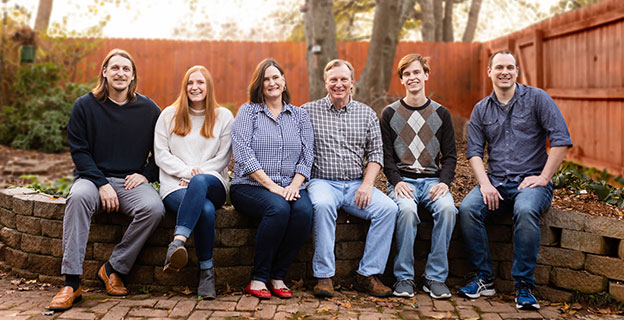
[459,183,553,286]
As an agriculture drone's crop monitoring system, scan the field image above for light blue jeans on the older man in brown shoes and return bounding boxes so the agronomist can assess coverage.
[308,179,397,278]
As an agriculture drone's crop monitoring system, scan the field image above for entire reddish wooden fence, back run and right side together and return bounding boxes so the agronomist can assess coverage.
[70,0,624,175]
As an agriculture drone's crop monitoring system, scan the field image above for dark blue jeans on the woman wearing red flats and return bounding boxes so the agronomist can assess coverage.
[230,184,312,283]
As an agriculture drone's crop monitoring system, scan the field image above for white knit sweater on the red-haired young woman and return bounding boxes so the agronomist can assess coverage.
[154,106,234,199]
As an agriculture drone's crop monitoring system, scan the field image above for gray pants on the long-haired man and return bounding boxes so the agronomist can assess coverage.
[61,177,165,275]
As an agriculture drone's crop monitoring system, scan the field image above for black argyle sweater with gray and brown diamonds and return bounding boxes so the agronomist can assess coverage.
[381,99,457,186]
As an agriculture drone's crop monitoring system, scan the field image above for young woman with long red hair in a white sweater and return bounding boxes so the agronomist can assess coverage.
[154,66,234,298]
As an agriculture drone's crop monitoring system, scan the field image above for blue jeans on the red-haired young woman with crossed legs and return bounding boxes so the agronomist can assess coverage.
[163,174,225,270]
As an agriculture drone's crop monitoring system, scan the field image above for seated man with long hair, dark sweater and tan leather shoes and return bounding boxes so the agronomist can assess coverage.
[49,49,165,311]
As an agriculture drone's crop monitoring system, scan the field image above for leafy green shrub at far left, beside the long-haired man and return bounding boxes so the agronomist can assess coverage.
[0,62,92,152]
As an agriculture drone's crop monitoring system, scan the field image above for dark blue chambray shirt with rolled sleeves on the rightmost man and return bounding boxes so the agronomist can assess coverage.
[466,83,572,187]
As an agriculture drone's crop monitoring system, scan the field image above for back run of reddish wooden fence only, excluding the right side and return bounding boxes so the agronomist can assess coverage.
[76,39,481,117]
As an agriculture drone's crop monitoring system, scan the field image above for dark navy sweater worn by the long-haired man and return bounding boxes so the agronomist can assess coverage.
[67,93,160,188]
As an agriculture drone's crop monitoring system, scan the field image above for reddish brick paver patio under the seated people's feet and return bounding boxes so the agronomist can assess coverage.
[0,275,617,320]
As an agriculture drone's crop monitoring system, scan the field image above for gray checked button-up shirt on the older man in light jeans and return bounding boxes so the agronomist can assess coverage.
[301,96,383,181]
